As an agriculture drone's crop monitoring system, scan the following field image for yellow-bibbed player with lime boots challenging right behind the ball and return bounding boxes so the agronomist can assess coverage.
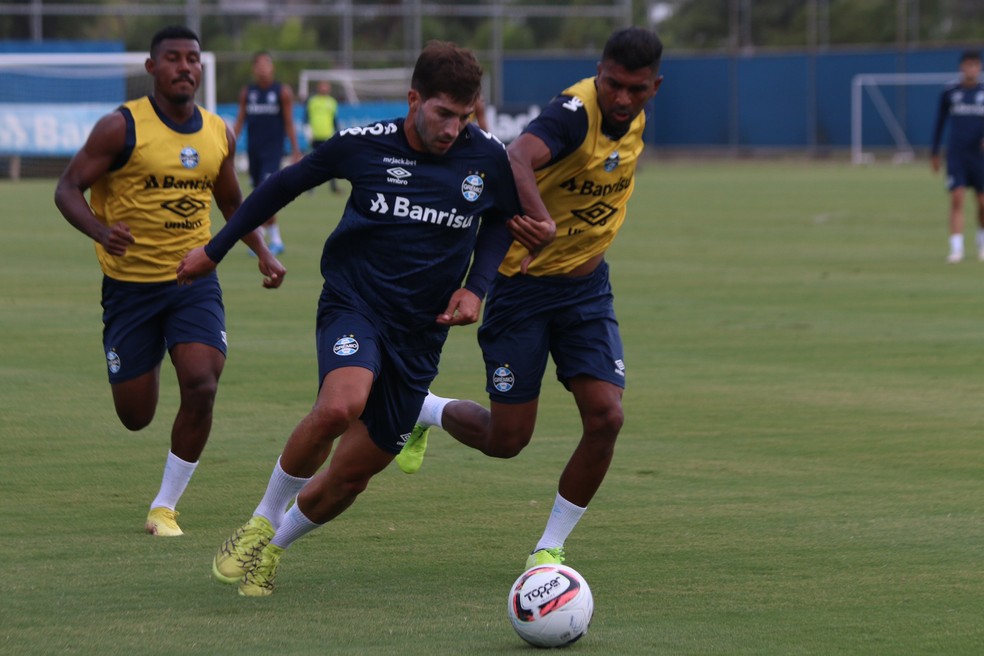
[397,28,663,568]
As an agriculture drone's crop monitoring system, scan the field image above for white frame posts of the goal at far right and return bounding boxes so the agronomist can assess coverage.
[851,71,959,164]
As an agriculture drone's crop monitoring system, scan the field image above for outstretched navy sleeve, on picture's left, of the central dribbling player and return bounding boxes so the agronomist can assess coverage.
[205,135,354,263]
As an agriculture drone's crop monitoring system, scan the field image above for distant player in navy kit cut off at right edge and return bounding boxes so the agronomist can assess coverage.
[931,50,984,264]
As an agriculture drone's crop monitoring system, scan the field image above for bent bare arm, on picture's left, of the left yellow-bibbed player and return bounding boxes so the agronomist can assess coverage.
[55,112,134,256]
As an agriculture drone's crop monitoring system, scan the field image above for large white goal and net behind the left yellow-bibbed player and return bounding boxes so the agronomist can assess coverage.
[0,52,215,178]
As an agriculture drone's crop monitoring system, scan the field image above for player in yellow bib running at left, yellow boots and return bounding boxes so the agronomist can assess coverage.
[55,26,285,537]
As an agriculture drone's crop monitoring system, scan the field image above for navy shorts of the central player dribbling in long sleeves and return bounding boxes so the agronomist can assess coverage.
[316,307,441,454]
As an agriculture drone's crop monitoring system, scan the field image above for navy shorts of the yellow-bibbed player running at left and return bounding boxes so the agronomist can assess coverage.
[102,272,226,383]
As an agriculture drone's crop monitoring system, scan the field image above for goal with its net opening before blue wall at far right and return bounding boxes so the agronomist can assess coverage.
[851,71,957,164]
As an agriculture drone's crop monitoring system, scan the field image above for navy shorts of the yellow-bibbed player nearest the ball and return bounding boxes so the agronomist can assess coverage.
[478,262,625,403]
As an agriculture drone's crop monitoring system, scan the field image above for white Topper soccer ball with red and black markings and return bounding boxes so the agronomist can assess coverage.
[509,565,594,647]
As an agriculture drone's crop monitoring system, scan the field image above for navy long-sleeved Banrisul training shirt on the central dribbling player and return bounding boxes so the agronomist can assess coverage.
[206,118,520,334]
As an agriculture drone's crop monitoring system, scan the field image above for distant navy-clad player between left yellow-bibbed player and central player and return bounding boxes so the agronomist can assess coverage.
[233,51,301,255]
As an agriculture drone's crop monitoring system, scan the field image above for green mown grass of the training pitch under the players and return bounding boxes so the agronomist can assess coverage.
[0,161,984,655]
